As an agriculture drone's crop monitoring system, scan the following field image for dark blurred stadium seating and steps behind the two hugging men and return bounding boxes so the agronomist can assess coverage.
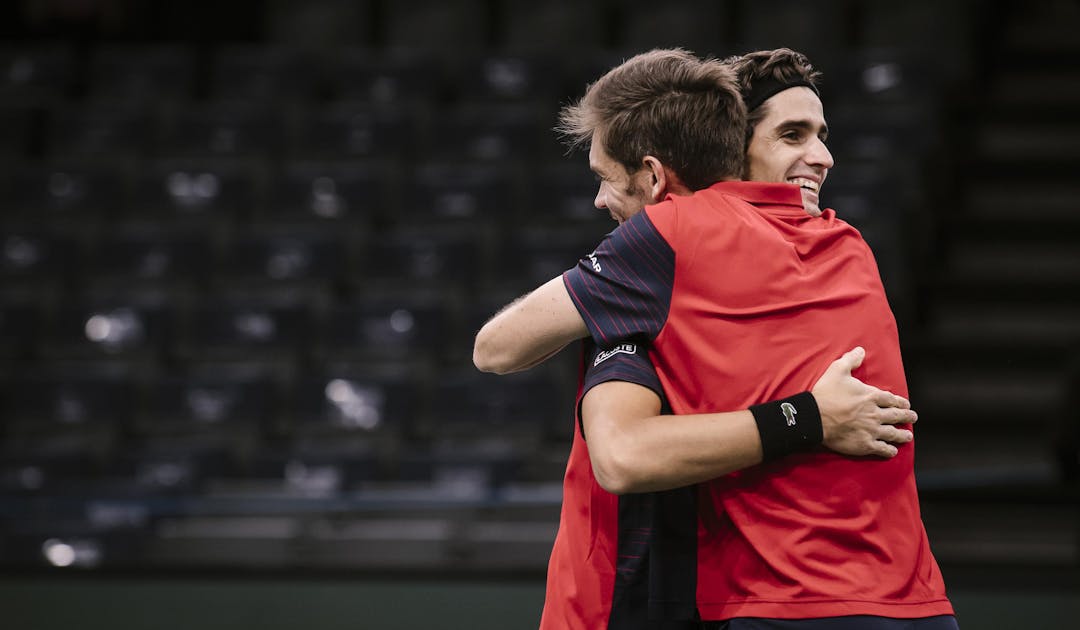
[0,0,1080,630]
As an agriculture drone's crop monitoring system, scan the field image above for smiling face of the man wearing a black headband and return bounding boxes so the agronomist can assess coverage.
[746,86,833,216]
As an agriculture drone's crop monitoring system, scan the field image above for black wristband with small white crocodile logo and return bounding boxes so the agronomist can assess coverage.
[750,391,824,461]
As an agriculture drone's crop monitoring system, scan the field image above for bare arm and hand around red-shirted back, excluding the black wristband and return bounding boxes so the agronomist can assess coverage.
[581,348,916,494]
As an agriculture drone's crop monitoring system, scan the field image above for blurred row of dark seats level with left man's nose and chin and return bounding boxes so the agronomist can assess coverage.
[0,158,603,229]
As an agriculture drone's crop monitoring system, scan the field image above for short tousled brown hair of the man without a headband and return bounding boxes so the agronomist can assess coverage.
[555,49,746,190]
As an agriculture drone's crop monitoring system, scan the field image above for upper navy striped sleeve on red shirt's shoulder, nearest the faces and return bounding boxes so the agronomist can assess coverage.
[563,212,675,348]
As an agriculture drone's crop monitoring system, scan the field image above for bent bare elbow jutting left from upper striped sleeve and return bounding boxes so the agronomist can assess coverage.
[473,277,589,374]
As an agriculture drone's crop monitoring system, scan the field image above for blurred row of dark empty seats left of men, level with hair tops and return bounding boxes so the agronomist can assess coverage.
[0,44,578,107]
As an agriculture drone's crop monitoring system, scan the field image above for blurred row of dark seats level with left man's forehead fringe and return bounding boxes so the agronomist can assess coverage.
[0,100,563,162]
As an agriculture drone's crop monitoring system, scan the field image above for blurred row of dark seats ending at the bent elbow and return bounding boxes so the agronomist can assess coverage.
[0,291,475,364]
